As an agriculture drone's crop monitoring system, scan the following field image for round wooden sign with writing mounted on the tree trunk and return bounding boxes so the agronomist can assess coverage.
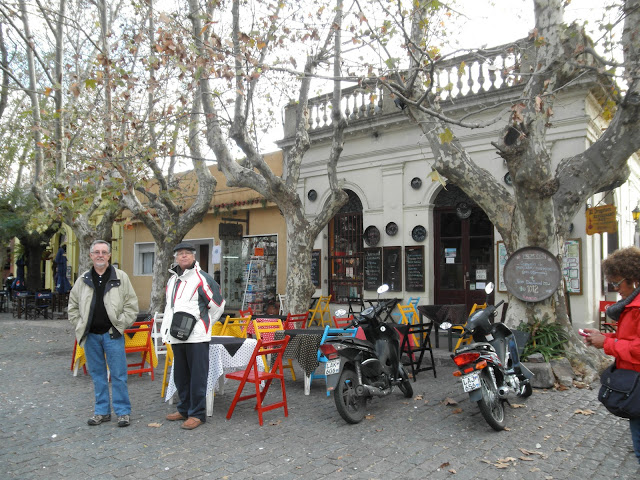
[504,247,562,302]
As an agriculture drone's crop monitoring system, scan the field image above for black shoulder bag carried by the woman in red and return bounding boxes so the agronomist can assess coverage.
[598,363,640,418]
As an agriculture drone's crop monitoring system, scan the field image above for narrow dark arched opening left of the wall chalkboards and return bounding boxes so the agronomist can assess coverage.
[328,190,363,303]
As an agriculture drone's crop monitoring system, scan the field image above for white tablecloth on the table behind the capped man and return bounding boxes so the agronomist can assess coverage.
[164,337,264,417]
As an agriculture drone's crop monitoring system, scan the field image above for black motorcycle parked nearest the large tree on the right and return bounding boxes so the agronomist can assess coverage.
[440,283,533,430]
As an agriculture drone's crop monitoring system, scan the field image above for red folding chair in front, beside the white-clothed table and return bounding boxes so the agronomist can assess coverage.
[225,335,289,426]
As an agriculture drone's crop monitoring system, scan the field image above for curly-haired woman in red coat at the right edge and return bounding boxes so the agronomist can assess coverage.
[585,247,640,462]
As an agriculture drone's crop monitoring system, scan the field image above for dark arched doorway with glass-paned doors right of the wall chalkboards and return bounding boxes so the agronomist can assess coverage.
[433,184,496,311]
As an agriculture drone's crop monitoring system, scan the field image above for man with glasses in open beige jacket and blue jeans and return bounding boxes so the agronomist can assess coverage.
[69,240,138,427]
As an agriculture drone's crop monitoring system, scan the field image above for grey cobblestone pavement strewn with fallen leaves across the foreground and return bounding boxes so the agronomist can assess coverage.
[0,314,640,480]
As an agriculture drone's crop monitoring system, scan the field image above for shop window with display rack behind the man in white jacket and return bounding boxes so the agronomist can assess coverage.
[220,235,278,314]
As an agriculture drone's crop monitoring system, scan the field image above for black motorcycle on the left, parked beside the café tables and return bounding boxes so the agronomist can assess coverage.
[320,285,413,423]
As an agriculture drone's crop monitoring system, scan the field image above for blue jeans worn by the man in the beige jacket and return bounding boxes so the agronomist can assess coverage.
[84,333,131,416]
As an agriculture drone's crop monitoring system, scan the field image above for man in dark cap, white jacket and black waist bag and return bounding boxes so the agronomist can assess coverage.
[162,242,225,430]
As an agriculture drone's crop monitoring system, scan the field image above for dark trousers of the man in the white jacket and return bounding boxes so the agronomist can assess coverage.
[171,342,209,422]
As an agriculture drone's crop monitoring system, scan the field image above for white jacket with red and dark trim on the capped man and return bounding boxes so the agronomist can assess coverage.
[161,262,225,344]
